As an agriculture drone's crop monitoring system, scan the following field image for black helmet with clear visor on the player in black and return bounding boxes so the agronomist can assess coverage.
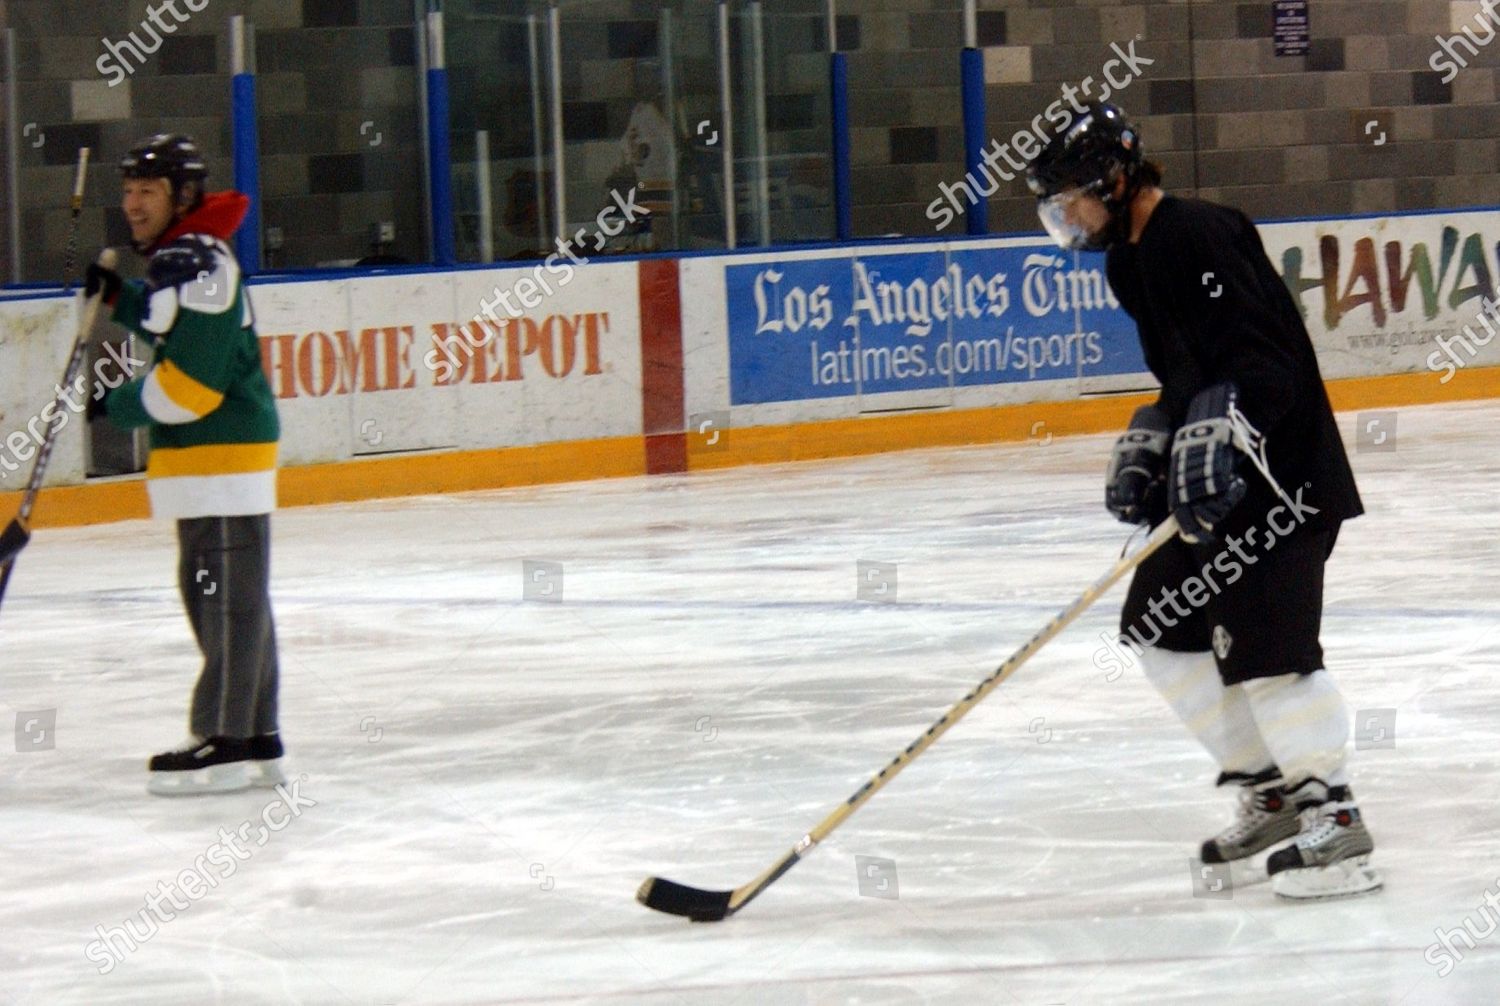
[1026,102,1142,250]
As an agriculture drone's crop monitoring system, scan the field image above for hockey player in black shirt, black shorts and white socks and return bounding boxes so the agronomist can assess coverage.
[1028,103,1380,898]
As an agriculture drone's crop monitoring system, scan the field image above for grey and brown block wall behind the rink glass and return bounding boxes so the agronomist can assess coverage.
[0,0,1500,279]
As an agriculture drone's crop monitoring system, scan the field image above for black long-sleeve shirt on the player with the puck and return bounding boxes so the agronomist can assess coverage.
[1106,195,1364,532]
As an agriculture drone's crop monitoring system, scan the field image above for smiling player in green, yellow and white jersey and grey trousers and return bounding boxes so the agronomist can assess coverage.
[87,133,284,795]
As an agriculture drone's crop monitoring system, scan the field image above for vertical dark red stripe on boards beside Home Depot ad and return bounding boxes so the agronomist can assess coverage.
[639,258,687,475]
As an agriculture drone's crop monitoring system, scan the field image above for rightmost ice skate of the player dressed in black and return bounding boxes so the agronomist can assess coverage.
[1266,780,1382,901]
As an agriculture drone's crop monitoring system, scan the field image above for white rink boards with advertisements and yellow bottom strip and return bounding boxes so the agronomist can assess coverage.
[0,202,1500,526]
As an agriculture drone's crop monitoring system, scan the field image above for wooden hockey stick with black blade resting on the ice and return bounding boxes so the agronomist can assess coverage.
[636,517,1178,922]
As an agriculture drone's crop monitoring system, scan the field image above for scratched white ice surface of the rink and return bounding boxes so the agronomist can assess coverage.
[0,403,1500,1006]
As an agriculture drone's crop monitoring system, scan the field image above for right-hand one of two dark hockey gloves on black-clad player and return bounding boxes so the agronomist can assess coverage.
[1167,382,1247,543]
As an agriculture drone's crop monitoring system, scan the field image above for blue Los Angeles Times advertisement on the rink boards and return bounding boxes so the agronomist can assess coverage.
[725,244,1146,405]
